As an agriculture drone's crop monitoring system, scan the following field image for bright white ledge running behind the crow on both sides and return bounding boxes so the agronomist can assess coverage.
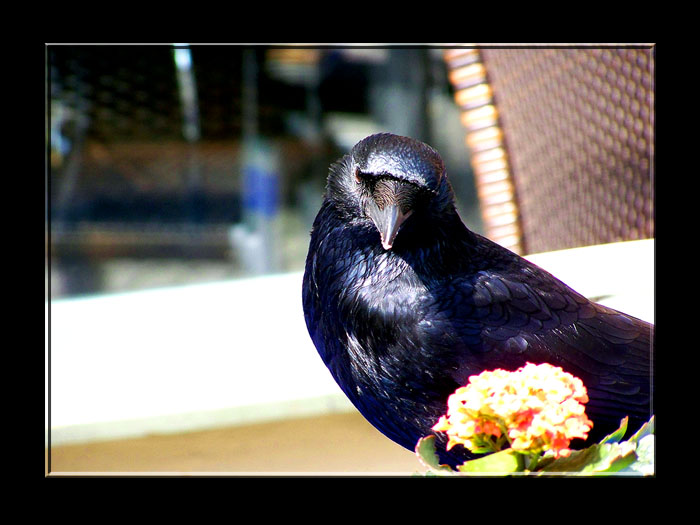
[45,240,654,446]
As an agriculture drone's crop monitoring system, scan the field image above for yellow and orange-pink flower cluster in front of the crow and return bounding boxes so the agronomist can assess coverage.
[433,363,593,457]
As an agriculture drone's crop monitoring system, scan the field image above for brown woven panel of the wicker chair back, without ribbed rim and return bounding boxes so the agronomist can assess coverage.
[480,48,654,253]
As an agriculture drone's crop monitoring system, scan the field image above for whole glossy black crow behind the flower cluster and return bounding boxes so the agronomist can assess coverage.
[303,134,653,465]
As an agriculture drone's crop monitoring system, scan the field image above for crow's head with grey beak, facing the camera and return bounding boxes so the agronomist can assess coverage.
[327,133,452,250]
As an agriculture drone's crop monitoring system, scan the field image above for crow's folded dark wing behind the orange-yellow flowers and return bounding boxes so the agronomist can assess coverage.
[446,263,653,434]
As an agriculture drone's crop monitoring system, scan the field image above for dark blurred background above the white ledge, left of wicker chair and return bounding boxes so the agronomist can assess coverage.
[47,45,479,299]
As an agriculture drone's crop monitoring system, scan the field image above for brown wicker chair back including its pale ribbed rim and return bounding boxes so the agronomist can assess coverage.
[445,46,654,253]
